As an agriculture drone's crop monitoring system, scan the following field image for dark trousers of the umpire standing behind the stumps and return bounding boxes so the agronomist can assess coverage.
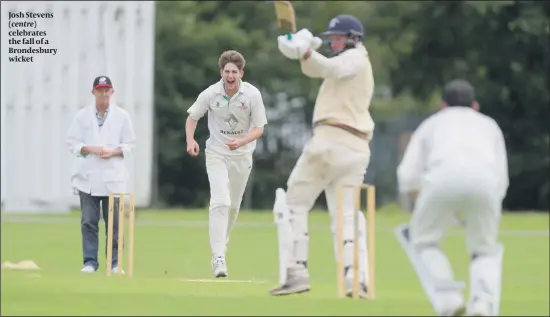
[79,191,119,270]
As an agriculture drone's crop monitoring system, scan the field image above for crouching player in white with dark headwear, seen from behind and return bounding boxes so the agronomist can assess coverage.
[396,80,508,316]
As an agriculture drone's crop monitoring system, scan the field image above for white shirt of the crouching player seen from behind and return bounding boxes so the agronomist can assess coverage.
[397,107,509,197]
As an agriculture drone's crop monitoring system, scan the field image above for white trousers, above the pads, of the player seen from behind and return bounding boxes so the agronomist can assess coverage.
[410,162,502,255]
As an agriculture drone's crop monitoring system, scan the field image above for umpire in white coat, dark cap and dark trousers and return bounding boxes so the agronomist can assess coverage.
[67,76,136,273]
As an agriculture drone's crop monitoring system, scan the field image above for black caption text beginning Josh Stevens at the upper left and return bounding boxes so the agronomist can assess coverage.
[8,11,57,63]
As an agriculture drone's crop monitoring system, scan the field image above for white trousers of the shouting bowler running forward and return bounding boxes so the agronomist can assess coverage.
[205,149,252,256]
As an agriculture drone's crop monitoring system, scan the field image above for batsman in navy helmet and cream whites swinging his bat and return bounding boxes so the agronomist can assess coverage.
[270,15,374,298]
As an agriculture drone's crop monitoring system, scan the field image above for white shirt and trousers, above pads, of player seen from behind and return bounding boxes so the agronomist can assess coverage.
[397,107,508,253]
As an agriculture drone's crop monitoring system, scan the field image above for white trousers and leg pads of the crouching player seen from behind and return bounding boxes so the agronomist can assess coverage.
[409,162,502,316]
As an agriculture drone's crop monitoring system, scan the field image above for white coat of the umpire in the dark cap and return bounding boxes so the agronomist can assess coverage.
[67,104,136,196]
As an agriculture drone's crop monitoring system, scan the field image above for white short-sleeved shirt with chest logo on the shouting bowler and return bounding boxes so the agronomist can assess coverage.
[187,79,267,155]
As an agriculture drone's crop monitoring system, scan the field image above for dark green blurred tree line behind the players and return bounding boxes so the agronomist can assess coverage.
[155,1,550,210]
